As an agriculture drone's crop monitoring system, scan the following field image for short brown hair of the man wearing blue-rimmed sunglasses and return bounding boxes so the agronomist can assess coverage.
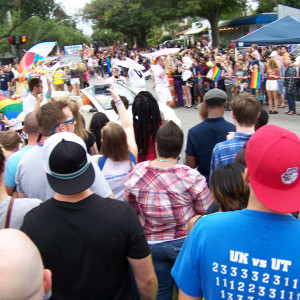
[36,101,68,136]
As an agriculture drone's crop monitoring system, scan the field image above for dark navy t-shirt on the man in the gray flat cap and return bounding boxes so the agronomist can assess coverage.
[185,117,235,183]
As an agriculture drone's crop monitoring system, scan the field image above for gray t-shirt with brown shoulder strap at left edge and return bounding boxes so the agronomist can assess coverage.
[0,197,43,229]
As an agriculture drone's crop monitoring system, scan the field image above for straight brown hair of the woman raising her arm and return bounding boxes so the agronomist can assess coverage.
[101,122,129,161]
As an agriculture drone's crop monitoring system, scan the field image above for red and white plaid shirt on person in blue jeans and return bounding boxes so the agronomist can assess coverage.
[124,161,213,241]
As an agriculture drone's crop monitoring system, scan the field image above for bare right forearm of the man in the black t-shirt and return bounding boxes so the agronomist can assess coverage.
[127,254,158,300]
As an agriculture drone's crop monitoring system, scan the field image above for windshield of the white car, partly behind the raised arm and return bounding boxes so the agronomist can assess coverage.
[86,83,136,110]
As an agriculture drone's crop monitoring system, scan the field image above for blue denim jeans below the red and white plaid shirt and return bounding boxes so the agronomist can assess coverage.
[149,238,185,300]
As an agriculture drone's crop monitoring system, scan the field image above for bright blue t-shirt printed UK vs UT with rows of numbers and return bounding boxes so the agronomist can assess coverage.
[172,209,300,300]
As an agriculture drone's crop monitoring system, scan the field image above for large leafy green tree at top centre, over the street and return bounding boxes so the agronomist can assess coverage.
[84,0,180,48]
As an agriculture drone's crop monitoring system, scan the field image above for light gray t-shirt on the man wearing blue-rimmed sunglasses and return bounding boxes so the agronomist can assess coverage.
[16,145,112,202]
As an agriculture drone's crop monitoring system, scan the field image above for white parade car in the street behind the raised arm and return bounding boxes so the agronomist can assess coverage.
[80,83,181,128]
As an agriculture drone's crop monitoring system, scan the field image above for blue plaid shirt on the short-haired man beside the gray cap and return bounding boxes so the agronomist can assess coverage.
[210,132,252,176]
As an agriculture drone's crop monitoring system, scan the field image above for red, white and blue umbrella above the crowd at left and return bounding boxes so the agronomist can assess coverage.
[18,42,56,73]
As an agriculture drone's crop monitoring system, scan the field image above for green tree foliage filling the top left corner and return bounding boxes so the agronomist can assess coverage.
[0,0,58,38]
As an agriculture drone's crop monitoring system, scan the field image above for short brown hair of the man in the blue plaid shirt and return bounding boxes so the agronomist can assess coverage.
[231,92,260,126]
